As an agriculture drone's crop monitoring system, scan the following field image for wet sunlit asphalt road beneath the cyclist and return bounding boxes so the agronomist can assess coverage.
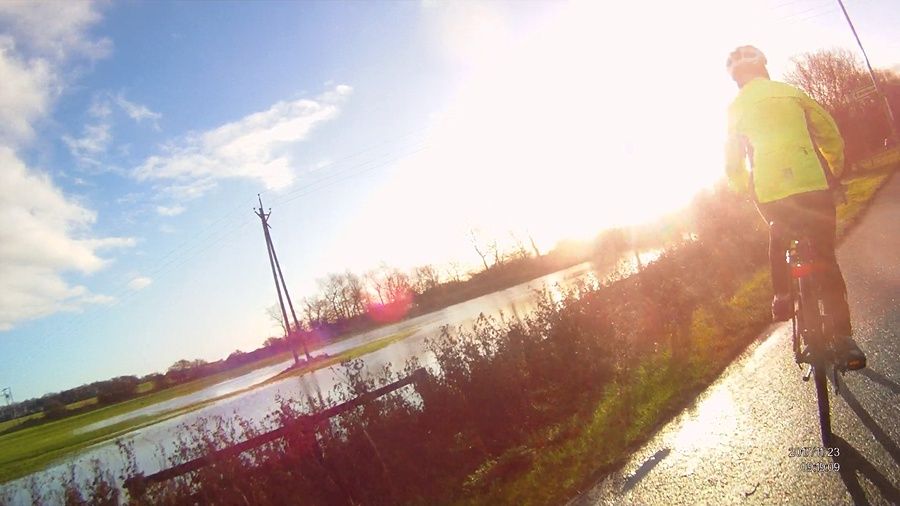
[571,176,900,506]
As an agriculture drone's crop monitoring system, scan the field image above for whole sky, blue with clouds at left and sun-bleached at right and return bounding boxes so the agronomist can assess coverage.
[0,0,900,400]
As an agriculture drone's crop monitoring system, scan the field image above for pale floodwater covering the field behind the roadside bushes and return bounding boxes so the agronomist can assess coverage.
[0,251,659,504]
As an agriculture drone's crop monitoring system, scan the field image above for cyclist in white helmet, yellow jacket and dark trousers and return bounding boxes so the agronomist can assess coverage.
[726,46,865,369]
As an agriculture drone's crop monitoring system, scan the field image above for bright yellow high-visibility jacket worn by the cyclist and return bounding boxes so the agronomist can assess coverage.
[725,78,844,202]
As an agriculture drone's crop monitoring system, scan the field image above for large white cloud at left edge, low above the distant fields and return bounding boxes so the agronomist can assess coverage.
[0,147,135,330]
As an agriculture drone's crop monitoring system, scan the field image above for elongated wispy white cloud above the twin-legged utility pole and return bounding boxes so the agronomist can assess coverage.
[134,85,352,197]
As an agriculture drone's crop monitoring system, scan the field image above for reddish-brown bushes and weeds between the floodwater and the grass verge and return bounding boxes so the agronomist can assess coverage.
[49,186,766,504]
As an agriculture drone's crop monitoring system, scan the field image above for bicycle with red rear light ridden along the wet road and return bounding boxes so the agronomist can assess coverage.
[785,232,852,447]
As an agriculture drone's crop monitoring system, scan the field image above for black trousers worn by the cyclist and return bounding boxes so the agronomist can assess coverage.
[757,190,851,336]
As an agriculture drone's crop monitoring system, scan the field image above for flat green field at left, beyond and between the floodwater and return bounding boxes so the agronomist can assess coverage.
[0,330,413,483]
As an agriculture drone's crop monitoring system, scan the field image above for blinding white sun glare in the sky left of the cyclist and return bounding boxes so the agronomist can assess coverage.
[333,2,848,274]
